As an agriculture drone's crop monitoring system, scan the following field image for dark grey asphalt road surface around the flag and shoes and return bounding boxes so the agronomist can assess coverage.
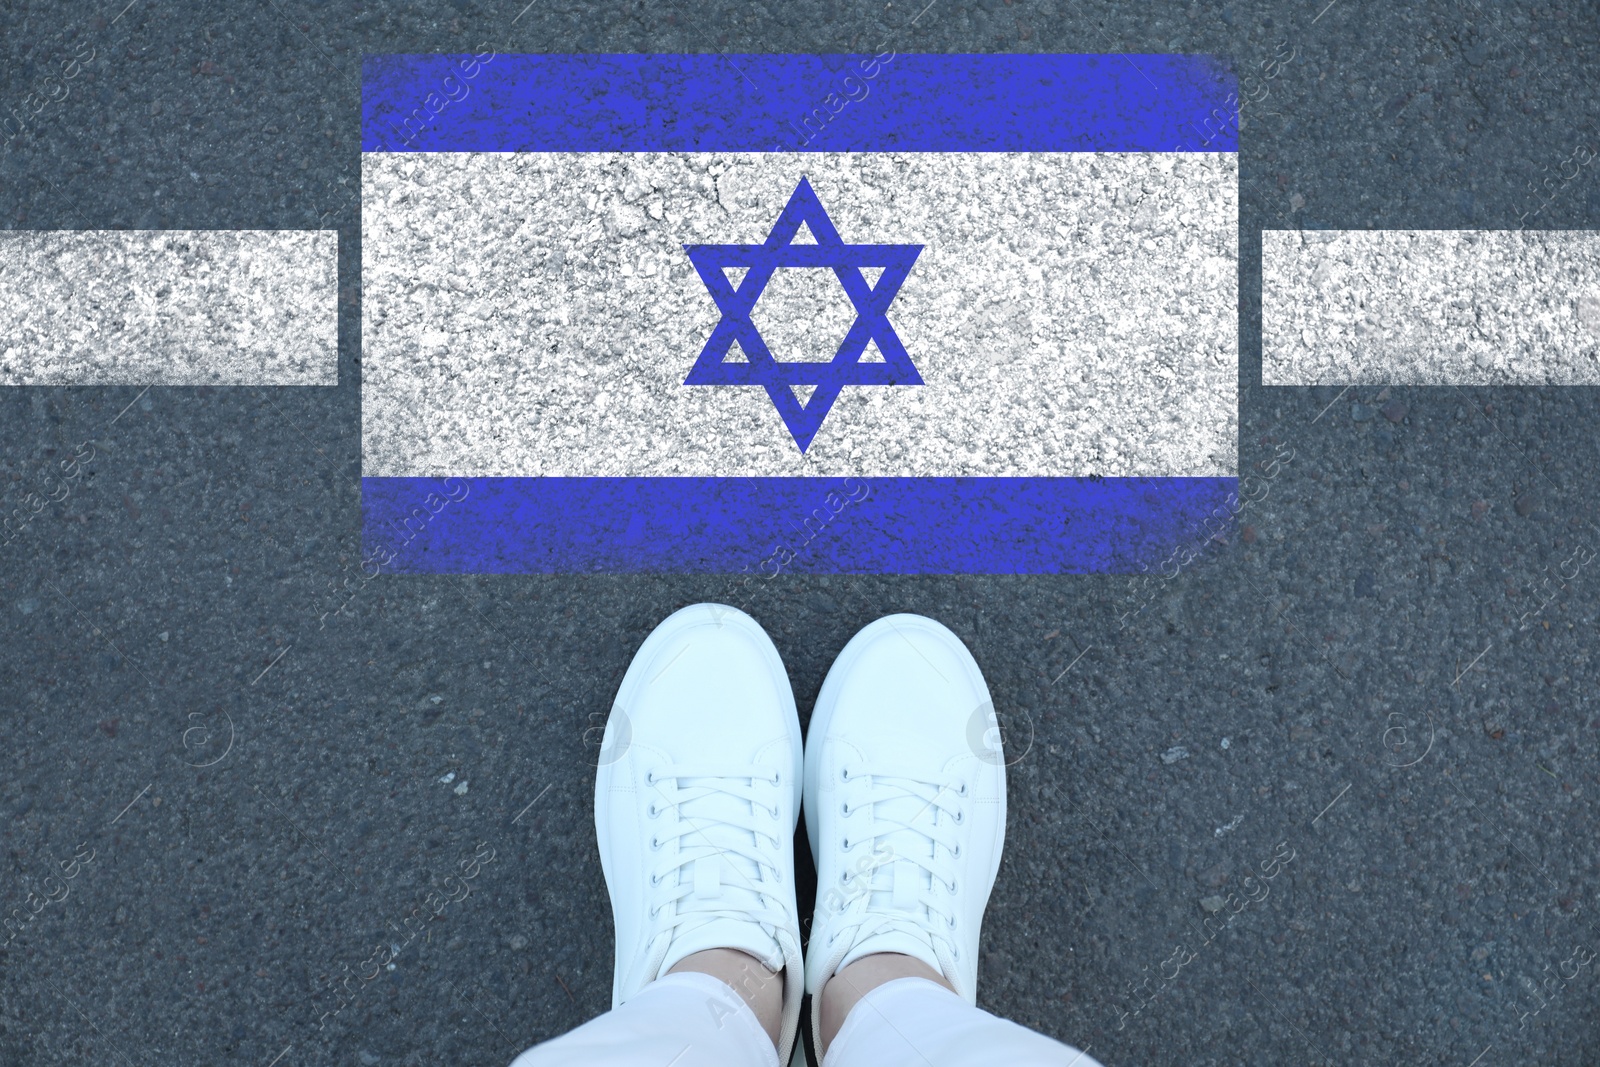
[0,0,1600,1067]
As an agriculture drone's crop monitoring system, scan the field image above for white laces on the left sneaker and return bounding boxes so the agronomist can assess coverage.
[645,766,789,944]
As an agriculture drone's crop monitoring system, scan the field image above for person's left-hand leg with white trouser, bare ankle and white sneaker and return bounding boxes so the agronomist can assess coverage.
[517,605,803,1067]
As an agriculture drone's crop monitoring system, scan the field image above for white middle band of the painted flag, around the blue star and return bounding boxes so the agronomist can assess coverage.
[362,152,1238,477]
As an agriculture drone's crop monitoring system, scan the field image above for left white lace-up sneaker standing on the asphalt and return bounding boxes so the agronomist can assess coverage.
[595,605,803,1062]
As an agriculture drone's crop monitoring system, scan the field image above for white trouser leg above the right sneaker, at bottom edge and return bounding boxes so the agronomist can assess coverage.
[822,977,1101,1067]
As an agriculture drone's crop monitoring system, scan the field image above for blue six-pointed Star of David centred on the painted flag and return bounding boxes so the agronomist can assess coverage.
[683,178,922,453]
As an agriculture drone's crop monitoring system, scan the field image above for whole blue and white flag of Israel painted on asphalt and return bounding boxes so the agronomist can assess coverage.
[362,53,1238,573]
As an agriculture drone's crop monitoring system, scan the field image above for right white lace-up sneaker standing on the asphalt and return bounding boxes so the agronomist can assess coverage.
[805,614,1005,1051]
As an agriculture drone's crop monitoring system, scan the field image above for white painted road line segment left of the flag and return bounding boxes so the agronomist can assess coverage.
[0,230,339,386]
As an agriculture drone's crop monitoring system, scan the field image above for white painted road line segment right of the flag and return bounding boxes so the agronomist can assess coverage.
[1261,230,1600,386]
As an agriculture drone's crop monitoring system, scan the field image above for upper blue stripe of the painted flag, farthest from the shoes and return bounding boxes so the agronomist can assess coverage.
[362,53,1238,152]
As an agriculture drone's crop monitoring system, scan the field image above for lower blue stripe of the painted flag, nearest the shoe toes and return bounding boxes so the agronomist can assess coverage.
[362,478,1238,576]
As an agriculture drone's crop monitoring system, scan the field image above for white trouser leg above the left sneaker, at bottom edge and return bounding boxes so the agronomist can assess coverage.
[512,971,779,1067]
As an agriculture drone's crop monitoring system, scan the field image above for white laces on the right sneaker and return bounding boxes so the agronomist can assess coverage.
[832,768,966,960]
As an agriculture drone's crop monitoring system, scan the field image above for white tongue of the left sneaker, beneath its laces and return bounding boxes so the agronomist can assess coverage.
[656,777,784,977]
